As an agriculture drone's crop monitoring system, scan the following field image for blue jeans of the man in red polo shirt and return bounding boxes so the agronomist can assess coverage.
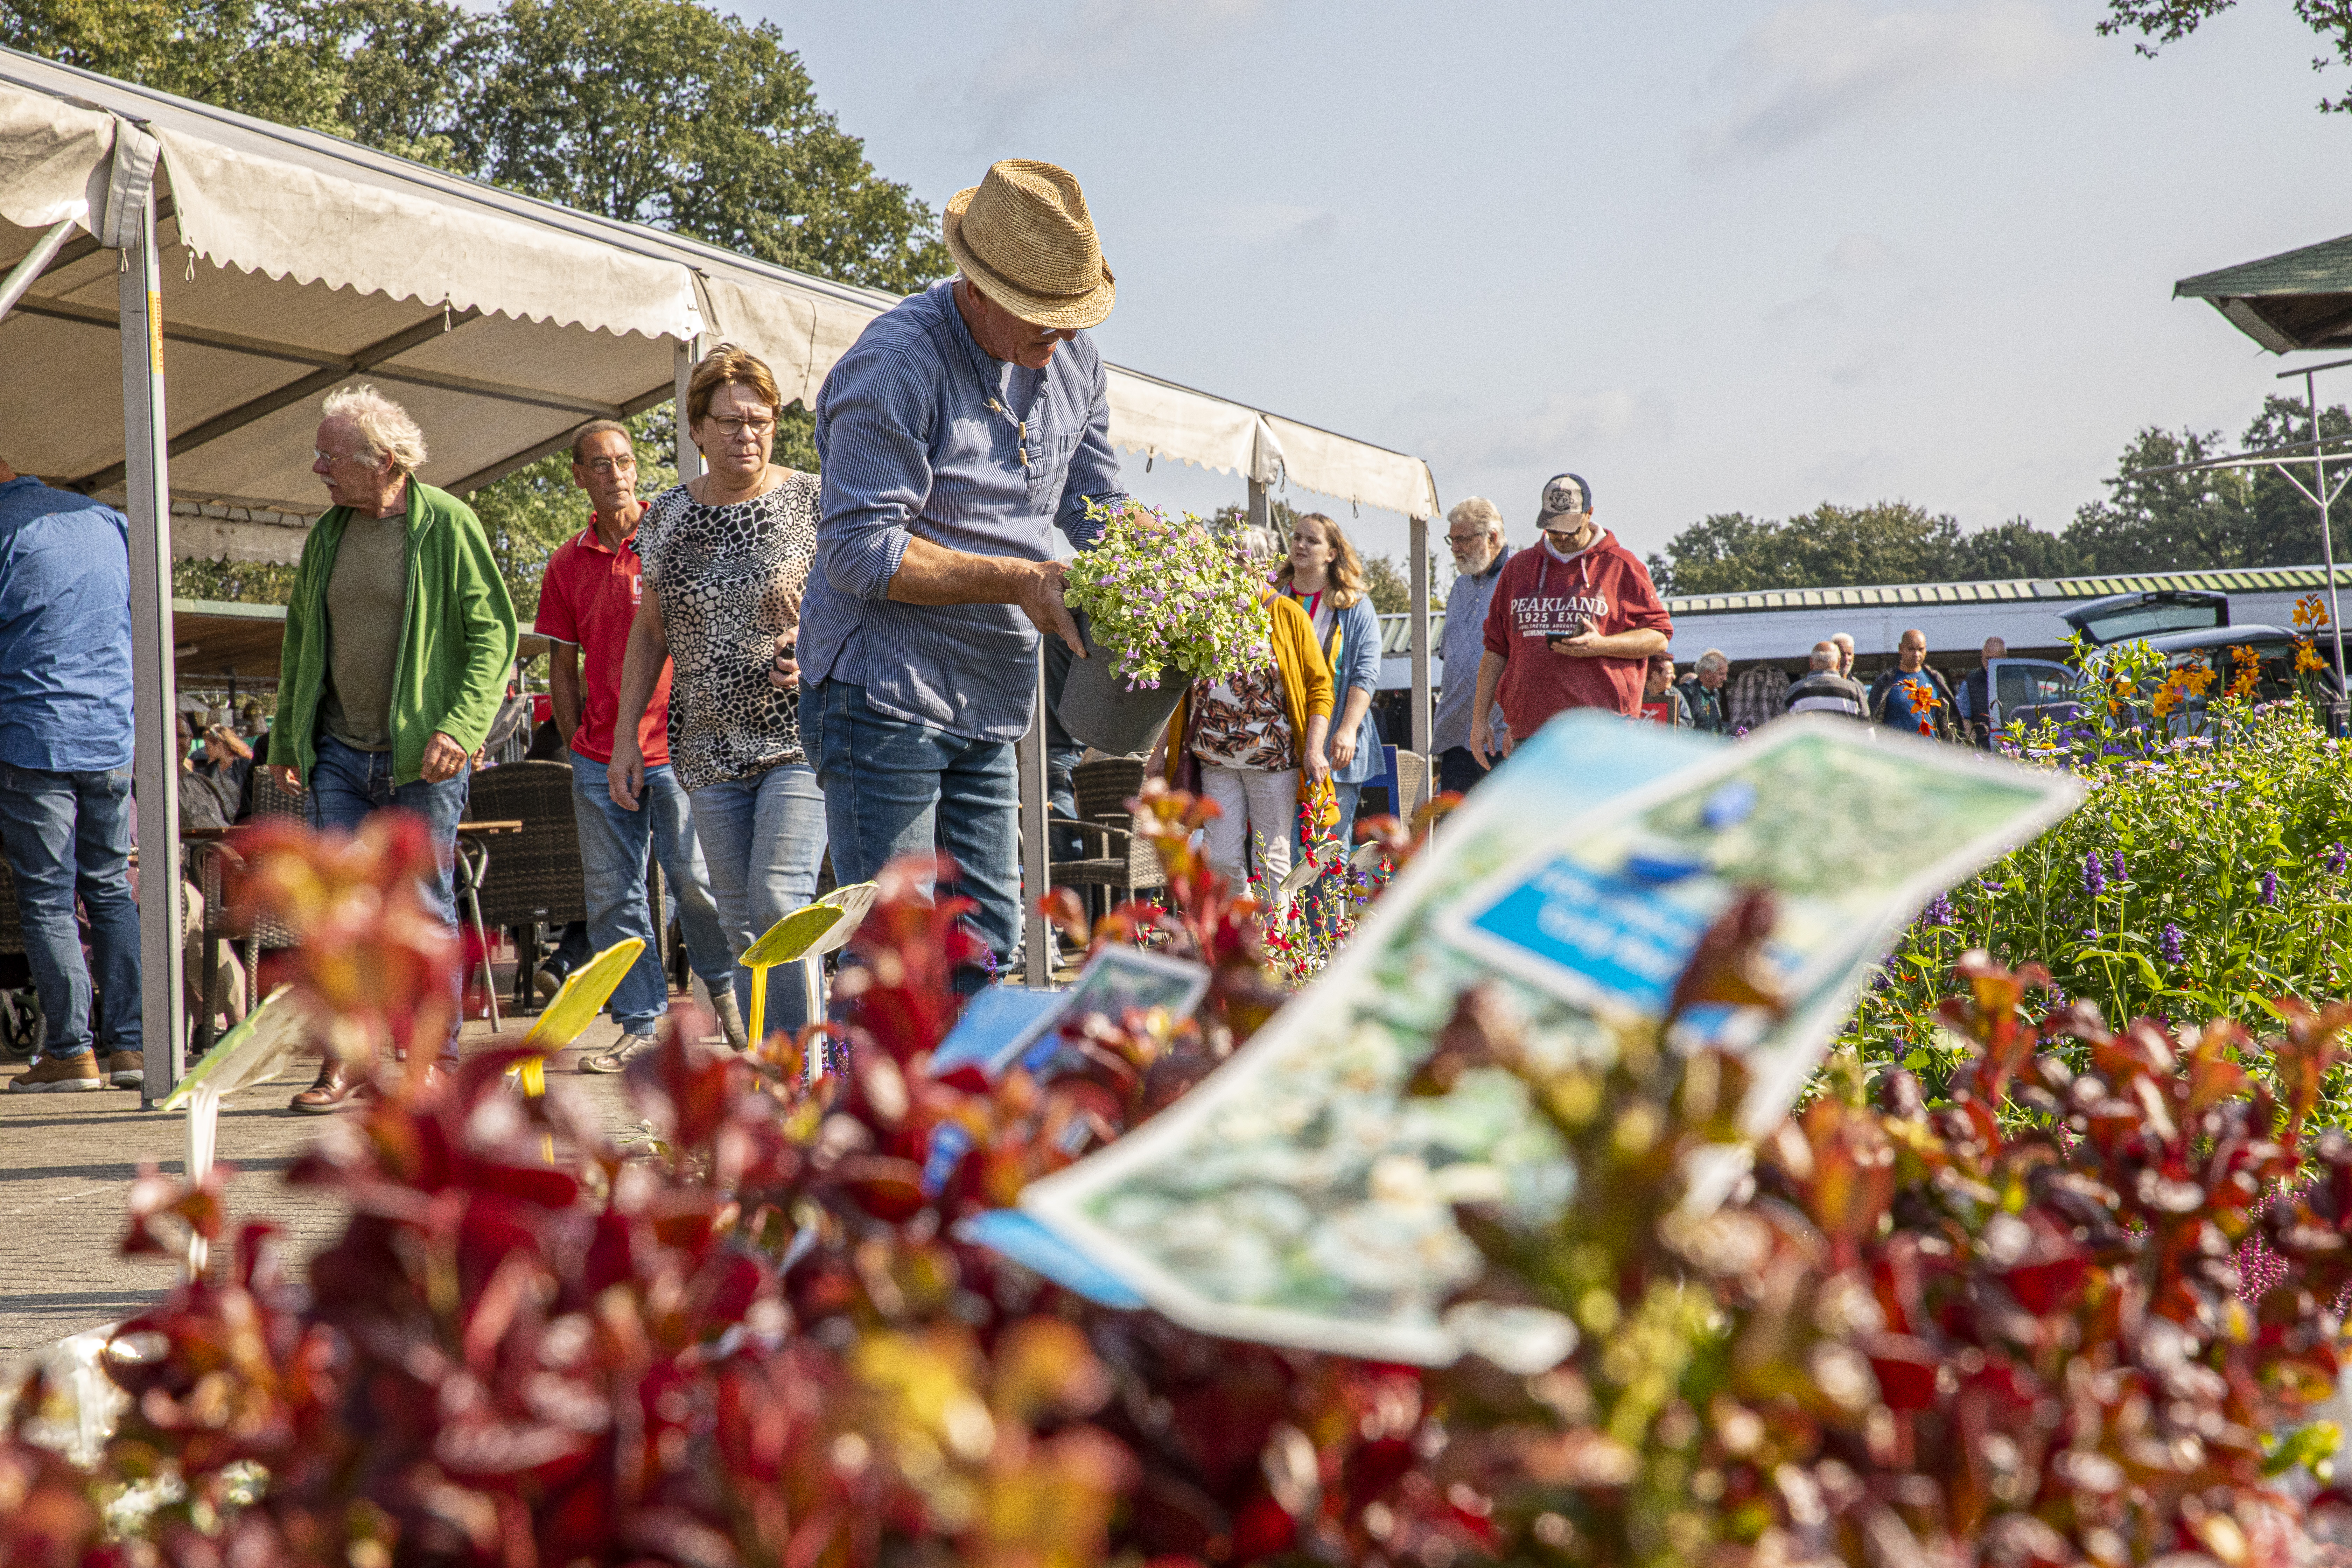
[569,752,734,1034]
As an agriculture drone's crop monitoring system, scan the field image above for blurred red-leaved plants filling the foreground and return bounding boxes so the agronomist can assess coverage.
[14,792,2352,1568]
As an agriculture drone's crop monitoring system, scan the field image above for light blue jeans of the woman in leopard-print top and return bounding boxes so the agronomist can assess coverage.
[687,762,826,1034]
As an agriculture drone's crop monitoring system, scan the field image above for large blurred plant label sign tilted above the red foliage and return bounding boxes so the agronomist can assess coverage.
[1021,712,2077,1366]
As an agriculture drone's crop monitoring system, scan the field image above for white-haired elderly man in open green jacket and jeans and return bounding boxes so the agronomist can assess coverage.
[268,386,515,1112]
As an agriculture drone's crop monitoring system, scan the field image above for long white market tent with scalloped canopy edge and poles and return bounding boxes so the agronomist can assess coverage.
[0,49,1437,1081]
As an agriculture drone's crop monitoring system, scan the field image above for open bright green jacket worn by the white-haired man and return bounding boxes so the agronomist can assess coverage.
[268,475,515,785]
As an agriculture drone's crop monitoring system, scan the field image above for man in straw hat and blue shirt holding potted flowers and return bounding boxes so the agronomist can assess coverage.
[804,160,1127,966]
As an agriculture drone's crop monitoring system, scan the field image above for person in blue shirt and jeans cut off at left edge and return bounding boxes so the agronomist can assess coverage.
[0,461,141,1093]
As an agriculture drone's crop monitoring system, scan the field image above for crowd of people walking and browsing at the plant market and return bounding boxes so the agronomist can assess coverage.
[0,150,2023,1112]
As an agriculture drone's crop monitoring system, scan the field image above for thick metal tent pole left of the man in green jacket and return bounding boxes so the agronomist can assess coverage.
[118,183,186,1107]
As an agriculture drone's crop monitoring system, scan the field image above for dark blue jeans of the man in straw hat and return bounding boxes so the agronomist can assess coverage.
[800,682,1021,990]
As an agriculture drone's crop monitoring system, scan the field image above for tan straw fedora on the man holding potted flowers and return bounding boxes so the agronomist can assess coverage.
[943,158,1117,331]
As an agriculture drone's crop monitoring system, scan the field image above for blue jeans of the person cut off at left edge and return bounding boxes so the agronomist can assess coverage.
[0,762,140,1060]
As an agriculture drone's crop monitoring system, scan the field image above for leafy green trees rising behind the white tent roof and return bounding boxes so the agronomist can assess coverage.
[0,0,950,616]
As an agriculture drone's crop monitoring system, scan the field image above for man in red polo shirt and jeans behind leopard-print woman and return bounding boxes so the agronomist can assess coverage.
[536,419,743,1072]
